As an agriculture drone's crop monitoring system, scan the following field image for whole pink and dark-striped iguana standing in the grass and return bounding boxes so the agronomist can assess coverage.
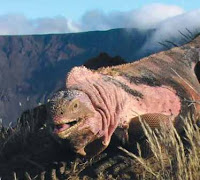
[50,37,200,155]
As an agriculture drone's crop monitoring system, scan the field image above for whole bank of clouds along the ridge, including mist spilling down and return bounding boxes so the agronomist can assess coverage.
[0,4,200,50]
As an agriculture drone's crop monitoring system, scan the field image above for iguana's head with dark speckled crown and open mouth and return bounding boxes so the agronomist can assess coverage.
[49,90,101,155]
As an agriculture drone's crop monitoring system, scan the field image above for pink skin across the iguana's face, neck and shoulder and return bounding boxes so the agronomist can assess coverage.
[48,67,181,155]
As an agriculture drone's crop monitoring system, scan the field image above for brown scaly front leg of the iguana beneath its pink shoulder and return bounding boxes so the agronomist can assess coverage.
[115,113,174,157]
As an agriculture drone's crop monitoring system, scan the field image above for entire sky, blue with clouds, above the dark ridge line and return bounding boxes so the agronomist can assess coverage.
[0,0,200,35]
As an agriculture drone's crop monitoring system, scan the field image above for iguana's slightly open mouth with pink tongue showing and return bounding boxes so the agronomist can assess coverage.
[54,118,81,134]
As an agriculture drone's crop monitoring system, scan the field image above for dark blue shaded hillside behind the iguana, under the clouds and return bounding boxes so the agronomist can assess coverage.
[0,29,192,124]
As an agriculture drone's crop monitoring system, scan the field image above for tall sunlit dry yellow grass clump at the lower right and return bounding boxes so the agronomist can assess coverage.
[120,118,200,180]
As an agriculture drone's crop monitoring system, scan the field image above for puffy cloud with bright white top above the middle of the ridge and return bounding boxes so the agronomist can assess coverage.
[81,4,184,30]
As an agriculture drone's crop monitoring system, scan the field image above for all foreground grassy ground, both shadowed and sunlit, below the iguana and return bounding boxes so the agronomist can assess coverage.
[0,113,200,180]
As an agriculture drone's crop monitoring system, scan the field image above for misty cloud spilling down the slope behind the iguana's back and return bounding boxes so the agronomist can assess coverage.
[142,9,200,52]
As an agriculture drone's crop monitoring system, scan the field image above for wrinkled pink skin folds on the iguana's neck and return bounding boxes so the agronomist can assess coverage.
[67,75,126,145]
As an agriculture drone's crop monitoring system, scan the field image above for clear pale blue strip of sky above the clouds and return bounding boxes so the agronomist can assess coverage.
[0,0,200,20]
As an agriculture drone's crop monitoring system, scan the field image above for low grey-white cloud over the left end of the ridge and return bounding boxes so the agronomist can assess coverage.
[0,14,80,35]
